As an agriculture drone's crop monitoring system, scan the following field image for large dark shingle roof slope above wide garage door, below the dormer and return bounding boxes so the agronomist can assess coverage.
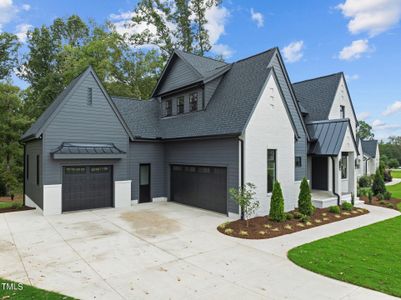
[113,48,282,139]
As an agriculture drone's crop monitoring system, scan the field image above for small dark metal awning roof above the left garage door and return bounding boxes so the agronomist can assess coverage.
[50,143,125,154]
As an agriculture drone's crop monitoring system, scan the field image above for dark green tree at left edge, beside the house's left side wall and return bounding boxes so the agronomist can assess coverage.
[0,83,30,195]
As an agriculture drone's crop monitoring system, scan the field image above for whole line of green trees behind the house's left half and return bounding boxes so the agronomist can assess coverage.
[0,0,221,196]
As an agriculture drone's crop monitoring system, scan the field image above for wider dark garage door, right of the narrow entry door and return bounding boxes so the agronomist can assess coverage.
[171,165,227,213]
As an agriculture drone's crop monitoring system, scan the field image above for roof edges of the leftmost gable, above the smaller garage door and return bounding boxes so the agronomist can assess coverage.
[21,66,132,142]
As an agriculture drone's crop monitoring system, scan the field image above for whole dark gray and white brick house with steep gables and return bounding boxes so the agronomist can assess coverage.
[22,48,358,215]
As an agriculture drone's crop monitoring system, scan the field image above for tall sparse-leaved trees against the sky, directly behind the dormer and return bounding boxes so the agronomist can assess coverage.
[129,0,221,59]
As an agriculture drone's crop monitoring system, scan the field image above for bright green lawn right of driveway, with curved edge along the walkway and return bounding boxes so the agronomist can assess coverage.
[288,216,401,297]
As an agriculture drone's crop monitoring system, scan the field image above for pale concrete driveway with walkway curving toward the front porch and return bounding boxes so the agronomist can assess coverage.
[0,203,398,300]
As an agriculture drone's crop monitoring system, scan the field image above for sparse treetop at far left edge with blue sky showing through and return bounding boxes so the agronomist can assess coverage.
[0,32,20,80]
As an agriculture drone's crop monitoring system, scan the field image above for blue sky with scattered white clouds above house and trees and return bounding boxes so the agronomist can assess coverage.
[0,0,401,138]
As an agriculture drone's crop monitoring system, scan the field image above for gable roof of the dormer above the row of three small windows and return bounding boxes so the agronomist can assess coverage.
[152,50,231,97]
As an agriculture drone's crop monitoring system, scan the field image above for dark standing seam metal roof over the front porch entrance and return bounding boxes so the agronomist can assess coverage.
[306,119,358,156]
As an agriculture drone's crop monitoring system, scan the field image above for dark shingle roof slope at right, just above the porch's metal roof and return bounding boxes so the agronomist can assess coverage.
[292,73,343,122]
